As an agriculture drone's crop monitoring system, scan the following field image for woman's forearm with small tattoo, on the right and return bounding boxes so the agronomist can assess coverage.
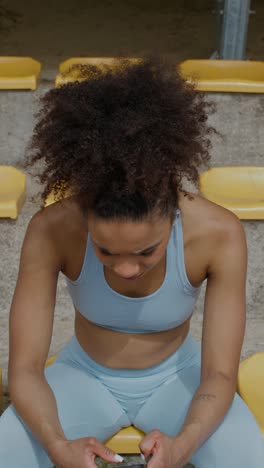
[177,375,236,457]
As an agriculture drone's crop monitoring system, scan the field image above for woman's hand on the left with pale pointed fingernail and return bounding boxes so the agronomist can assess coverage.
[49,437,122,468]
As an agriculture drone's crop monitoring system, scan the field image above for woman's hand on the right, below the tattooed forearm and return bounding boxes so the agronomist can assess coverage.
[139,429,189,468]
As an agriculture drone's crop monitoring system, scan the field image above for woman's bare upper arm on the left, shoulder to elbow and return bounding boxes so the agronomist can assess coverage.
[9,212,61,379]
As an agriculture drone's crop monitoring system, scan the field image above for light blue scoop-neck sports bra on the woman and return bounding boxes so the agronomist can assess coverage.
[66,210,200,333]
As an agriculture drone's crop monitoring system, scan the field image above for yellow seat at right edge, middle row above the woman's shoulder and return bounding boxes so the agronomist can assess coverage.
[200,166,264,219]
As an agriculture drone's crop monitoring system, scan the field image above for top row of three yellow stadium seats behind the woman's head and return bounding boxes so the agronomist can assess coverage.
[0,57,264,93]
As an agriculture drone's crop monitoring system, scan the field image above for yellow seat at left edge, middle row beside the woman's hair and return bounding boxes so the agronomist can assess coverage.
[0,166,26,219]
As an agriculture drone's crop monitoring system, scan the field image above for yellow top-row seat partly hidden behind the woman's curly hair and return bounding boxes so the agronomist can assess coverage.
[55,57,140,86]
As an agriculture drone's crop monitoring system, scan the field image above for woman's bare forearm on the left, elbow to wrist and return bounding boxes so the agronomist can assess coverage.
[10,370,65,453]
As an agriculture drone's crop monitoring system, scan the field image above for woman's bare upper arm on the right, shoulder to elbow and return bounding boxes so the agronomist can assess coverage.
[202,214,247,382]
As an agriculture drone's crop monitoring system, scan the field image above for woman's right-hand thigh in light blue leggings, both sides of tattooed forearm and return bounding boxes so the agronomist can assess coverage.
[133,365,264,468]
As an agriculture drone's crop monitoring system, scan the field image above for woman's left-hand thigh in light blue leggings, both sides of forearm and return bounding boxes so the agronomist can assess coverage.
[0,363,129,468]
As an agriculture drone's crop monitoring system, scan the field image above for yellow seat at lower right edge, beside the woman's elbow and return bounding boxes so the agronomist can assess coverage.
[238,353,264,435]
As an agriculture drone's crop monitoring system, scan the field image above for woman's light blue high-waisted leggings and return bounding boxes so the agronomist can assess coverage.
[0,335,264,468]
